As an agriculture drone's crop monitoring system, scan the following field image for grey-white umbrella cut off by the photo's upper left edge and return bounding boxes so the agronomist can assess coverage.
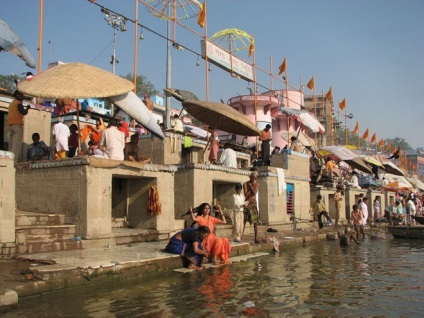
[0,20,35,68]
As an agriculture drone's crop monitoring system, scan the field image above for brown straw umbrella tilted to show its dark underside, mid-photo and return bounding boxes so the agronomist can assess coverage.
[183,100,260,136]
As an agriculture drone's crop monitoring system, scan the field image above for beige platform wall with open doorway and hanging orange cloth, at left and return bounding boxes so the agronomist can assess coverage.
[16,158,175,237]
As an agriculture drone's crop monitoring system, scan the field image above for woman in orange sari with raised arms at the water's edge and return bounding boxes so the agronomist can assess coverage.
[190,203,231,265]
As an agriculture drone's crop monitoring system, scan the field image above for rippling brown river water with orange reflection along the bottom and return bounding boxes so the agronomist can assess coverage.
[2,232,424,318]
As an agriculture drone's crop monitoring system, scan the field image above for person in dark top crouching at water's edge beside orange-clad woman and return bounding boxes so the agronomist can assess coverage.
[165,226,210,270]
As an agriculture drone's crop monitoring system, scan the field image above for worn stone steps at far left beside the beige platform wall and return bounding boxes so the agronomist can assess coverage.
[15,211,82,254]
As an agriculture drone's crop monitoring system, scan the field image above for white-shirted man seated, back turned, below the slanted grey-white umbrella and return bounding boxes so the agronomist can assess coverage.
[100,118,125,160]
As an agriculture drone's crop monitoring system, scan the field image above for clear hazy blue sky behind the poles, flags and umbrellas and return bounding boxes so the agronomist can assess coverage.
[0,0,424,147]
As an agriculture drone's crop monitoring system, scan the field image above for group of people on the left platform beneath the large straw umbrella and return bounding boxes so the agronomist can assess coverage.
[7,90,156,163]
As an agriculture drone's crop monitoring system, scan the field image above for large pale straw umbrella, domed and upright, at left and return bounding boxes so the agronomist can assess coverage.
[18,63,134,99]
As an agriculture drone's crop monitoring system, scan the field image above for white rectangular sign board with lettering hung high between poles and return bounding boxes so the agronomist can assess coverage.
[200,40,253,81]
